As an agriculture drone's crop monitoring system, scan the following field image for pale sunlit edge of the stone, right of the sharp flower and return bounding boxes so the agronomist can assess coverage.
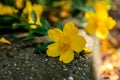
[79,30,102,80]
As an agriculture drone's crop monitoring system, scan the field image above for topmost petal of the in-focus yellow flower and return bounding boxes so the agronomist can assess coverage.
[63,22,78,36]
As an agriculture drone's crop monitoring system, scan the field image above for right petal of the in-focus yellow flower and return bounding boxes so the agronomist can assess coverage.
[71,36,86,52]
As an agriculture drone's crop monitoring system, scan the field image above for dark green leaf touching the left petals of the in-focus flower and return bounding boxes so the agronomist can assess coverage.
[34,41,54,53]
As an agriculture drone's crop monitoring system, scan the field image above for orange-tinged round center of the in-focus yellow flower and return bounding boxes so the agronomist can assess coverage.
[58,36,71,51]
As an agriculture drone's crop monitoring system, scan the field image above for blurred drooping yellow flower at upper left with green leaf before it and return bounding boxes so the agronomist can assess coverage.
[23,0,43,28]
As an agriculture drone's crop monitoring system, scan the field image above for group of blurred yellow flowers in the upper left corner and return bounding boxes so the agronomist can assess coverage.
[0,0,43,28]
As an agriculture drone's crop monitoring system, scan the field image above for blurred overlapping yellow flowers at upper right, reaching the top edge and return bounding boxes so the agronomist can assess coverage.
[85,0,116,39]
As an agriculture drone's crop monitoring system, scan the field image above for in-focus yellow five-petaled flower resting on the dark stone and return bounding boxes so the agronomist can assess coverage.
[47,22,86,63]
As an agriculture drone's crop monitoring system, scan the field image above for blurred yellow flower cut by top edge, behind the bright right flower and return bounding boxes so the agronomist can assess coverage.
[87,0,112,10]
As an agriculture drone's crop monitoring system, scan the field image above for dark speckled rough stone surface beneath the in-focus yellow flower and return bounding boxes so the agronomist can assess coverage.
[0,33,93,80]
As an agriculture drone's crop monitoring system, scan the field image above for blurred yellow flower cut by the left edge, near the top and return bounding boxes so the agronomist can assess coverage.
[0,3,18,15]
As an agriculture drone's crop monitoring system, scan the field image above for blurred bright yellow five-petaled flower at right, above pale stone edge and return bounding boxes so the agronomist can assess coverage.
[85,10,116,39]
